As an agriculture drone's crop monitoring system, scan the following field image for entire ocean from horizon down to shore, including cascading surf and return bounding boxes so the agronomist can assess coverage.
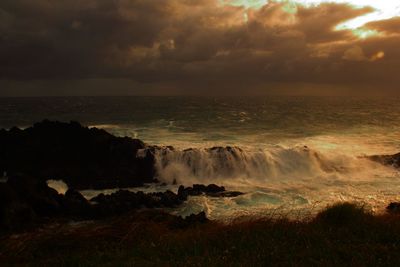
[0,96,400,220]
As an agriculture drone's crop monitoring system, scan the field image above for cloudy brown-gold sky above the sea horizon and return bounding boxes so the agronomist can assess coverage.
[0,0,400,96]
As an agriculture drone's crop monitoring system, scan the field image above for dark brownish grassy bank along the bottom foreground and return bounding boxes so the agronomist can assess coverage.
[0,203,400,266]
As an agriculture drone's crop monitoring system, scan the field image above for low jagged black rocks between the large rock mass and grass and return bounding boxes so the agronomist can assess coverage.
[0,175,236,231]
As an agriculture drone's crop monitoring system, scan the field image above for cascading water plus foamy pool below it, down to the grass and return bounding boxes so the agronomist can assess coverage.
[148,143,400,220]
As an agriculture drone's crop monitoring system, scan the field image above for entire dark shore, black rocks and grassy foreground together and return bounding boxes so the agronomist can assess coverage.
[0,121,400,266]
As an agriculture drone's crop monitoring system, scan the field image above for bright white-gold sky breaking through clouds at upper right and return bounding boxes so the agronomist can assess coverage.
[221,0,400,39]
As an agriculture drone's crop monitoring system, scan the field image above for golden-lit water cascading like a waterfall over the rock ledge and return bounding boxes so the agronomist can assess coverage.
[145,146,384,184]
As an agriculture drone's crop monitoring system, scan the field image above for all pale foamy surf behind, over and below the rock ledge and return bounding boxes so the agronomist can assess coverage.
[84,121,400,220]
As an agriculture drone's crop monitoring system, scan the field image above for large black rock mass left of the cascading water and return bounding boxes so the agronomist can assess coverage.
[0,120,154,190]
